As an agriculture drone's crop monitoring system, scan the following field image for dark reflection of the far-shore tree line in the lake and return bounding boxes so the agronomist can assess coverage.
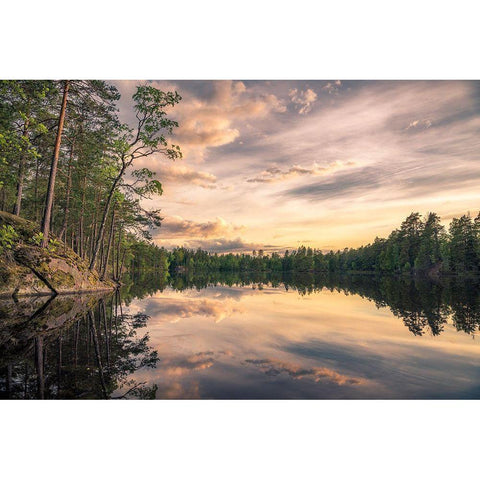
[126,272,480,336]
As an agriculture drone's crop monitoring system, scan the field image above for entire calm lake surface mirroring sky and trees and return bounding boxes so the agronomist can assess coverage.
[0,274,480,399]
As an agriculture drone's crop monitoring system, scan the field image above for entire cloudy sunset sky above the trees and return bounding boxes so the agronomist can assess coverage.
[112,80,480,253]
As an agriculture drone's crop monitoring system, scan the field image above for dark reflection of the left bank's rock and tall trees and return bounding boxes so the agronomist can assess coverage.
[0,292,158,399]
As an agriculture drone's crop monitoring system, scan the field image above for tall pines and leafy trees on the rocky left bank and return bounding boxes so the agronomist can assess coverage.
[0,80,182,280]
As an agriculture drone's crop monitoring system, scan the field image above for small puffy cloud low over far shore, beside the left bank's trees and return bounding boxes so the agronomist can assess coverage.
[157,216,243,240]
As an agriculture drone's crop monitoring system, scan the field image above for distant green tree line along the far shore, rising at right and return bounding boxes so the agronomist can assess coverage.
[162,213,480,274]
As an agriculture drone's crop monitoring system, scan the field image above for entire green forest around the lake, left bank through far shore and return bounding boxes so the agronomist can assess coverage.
[0,80,480,281]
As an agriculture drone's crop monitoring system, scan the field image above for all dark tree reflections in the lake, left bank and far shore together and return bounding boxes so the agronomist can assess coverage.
[0,272,480,399]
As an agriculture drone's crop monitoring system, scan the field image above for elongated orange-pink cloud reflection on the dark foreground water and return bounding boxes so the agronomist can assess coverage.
[245,358,365,385]
